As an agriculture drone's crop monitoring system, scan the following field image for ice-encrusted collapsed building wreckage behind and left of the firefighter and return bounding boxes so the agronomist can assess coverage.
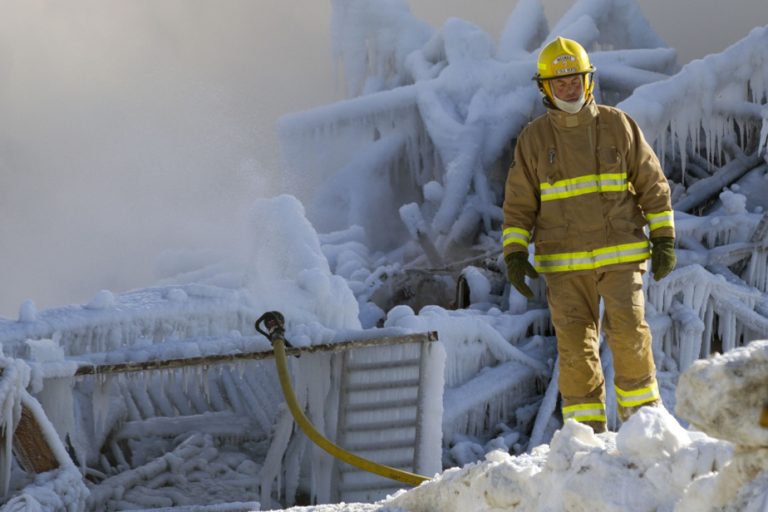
[0,0,768,510]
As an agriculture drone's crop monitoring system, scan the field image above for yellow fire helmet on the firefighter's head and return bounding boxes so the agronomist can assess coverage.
[533,37,595,108]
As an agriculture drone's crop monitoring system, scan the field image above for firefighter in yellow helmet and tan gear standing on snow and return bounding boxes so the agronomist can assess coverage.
[502,37,676,432]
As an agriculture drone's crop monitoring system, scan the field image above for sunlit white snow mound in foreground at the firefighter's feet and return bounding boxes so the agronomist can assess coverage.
[384,407,732,512]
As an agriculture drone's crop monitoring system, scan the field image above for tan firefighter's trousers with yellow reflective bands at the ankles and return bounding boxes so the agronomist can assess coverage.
[545,269,659,431]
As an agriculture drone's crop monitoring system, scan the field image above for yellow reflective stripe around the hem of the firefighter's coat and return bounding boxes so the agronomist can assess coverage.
[533,240,651,272]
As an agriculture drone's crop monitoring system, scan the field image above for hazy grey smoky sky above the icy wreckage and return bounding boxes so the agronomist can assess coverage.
[0,0,768,318]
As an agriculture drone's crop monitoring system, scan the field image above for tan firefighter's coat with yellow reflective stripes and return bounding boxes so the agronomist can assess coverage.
[503,96,674,272]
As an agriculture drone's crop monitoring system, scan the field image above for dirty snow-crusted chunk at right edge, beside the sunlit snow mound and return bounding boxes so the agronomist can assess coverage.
[675,340,768,447]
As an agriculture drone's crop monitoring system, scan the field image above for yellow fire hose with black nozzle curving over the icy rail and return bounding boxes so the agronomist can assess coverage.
[256,311,430,487]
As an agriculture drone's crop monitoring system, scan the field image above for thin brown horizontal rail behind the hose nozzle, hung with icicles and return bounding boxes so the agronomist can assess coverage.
[75,331,437,376]
